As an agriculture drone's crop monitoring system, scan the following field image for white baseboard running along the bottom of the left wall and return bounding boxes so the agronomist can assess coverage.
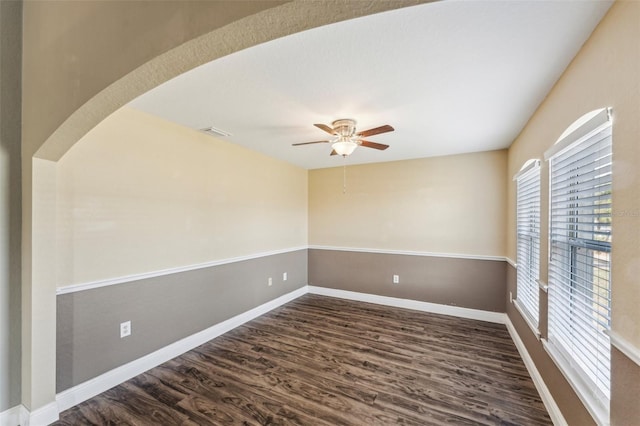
[56,286,308,412]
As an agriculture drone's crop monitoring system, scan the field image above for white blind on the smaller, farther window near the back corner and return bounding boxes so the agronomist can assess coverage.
[515,160,540,328]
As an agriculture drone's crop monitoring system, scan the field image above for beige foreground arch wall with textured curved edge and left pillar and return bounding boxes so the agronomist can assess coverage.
[21,0,427,424]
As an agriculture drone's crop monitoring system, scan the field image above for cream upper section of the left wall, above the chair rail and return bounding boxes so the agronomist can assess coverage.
[57,107,308,287]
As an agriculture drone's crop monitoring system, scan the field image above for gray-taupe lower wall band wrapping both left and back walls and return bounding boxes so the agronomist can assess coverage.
[56,249,506,392]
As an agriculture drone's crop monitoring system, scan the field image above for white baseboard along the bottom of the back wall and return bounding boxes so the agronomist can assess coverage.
[309,286,506,324]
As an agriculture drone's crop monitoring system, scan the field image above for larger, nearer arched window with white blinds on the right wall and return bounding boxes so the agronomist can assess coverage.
[547,110,612,423]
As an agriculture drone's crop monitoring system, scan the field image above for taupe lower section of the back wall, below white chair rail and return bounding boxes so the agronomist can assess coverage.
[309,249,507,312]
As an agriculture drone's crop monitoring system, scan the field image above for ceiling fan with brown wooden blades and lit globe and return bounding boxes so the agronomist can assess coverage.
[293,118,394,157]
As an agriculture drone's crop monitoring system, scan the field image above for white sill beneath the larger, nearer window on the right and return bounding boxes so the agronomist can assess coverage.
[542,339,609,426]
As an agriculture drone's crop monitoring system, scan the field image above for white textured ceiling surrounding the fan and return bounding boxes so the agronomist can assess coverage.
[131,0,611,169]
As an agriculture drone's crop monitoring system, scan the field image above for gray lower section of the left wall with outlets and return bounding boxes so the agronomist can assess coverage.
[56,250,308,392]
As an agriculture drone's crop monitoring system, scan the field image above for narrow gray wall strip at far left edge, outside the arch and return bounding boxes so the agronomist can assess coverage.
[0,1,22,413]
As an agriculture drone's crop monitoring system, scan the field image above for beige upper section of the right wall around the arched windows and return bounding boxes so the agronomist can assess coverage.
[507,1,640,348]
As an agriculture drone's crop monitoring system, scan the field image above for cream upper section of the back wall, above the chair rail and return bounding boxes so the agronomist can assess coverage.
[309,150,507,256]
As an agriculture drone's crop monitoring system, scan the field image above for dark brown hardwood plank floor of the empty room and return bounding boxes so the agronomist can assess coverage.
[55,295,551,426]
